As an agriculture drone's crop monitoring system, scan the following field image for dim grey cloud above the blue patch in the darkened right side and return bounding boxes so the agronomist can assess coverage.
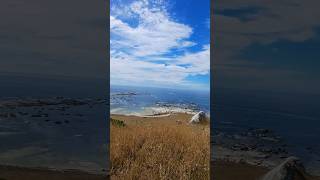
[214,0,320,63]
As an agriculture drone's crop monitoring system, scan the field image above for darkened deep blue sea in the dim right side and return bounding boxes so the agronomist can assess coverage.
[211,89,320,175]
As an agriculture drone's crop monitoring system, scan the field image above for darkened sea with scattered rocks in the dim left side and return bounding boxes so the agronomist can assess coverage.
[0,75,109,174]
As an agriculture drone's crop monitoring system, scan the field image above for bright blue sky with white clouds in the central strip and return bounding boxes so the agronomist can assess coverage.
[110,0,210,89]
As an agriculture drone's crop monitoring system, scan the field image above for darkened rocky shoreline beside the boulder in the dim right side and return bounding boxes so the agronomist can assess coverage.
[211,128,319,175]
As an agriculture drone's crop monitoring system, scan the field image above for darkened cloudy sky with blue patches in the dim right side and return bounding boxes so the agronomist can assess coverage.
[213,0,320,94]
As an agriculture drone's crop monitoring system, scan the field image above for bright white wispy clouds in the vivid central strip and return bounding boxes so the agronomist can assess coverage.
[110,0,210,89]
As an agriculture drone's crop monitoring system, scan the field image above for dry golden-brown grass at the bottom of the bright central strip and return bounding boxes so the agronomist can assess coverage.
[110,115,210,180]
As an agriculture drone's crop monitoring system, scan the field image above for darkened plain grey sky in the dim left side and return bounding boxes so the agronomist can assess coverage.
[0,0,108,80]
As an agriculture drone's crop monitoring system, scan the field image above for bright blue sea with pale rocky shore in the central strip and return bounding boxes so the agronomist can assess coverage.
[110,86,210,115]
